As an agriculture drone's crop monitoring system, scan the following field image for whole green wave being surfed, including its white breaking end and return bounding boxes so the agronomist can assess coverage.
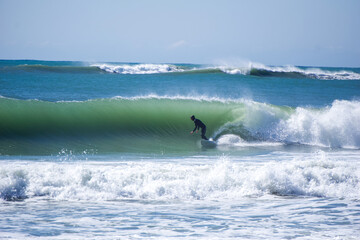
[0,95,360,154]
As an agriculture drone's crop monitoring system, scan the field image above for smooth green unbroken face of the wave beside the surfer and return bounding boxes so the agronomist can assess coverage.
[0,98,250,154]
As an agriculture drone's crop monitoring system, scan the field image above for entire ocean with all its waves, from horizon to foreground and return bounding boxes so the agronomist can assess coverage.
[0,60,360,239]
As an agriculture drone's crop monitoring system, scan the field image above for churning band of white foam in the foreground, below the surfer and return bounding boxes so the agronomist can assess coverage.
[0,153,360,201]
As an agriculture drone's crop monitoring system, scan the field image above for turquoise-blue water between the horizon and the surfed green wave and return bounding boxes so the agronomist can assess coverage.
[0,61,360,107]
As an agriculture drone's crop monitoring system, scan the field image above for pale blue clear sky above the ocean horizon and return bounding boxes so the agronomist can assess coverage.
[0,0,360,67]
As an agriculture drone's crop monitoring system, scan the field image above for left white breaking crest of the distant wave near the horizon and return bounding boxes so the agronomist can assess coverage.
[92,64,184,74]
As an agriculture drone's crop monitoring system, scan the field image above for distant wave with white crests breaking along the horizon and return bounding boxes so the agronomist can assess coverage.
[0,63,360,80]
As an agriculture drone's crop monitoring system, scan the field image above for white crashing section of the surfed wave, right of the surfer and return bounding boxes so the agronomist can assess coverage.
[214,100,360,149]
